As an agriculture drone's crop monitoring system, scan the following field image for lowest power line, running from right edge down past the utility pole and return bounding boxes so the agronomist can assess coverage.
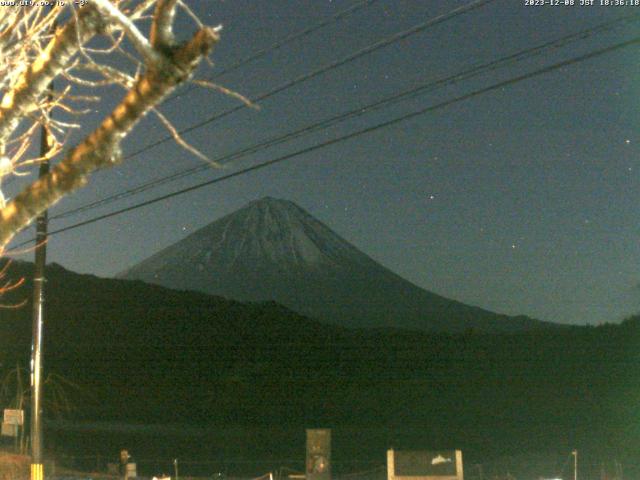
[14,33,640,249]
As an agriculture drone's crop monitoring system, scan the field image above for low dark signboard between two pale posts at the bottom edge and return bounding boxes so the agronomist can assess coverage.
[387,449,464,480]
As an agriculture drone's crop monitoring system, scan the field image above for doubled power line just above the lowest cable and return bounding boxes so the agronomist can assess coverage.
[51,14,640,220]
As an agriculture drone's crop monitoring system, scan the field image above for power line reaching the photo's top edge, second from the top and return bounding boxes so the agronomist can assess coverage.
[123,0,496,160]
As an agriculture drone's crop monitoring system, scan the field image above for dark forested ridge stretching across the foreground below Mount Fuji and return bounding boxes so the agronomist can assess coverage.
[0,262,640,478]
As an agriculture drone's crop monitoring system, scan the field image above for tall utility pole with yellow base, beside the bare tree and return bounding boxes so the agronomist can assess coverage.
[31,95,53,480]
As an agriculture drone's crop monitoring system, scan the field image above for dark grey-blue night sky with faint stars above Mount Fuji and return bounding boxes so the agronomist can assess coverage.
[9,0,640,324]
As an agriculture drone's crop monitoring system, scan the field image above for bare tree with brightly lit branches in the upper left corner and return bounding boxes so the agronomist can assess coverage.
[0,0,219,247]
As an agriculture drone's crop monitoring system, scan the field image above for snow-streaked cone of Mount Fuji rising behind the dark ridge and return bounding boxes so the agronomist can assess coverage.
[118,197,552,332]
